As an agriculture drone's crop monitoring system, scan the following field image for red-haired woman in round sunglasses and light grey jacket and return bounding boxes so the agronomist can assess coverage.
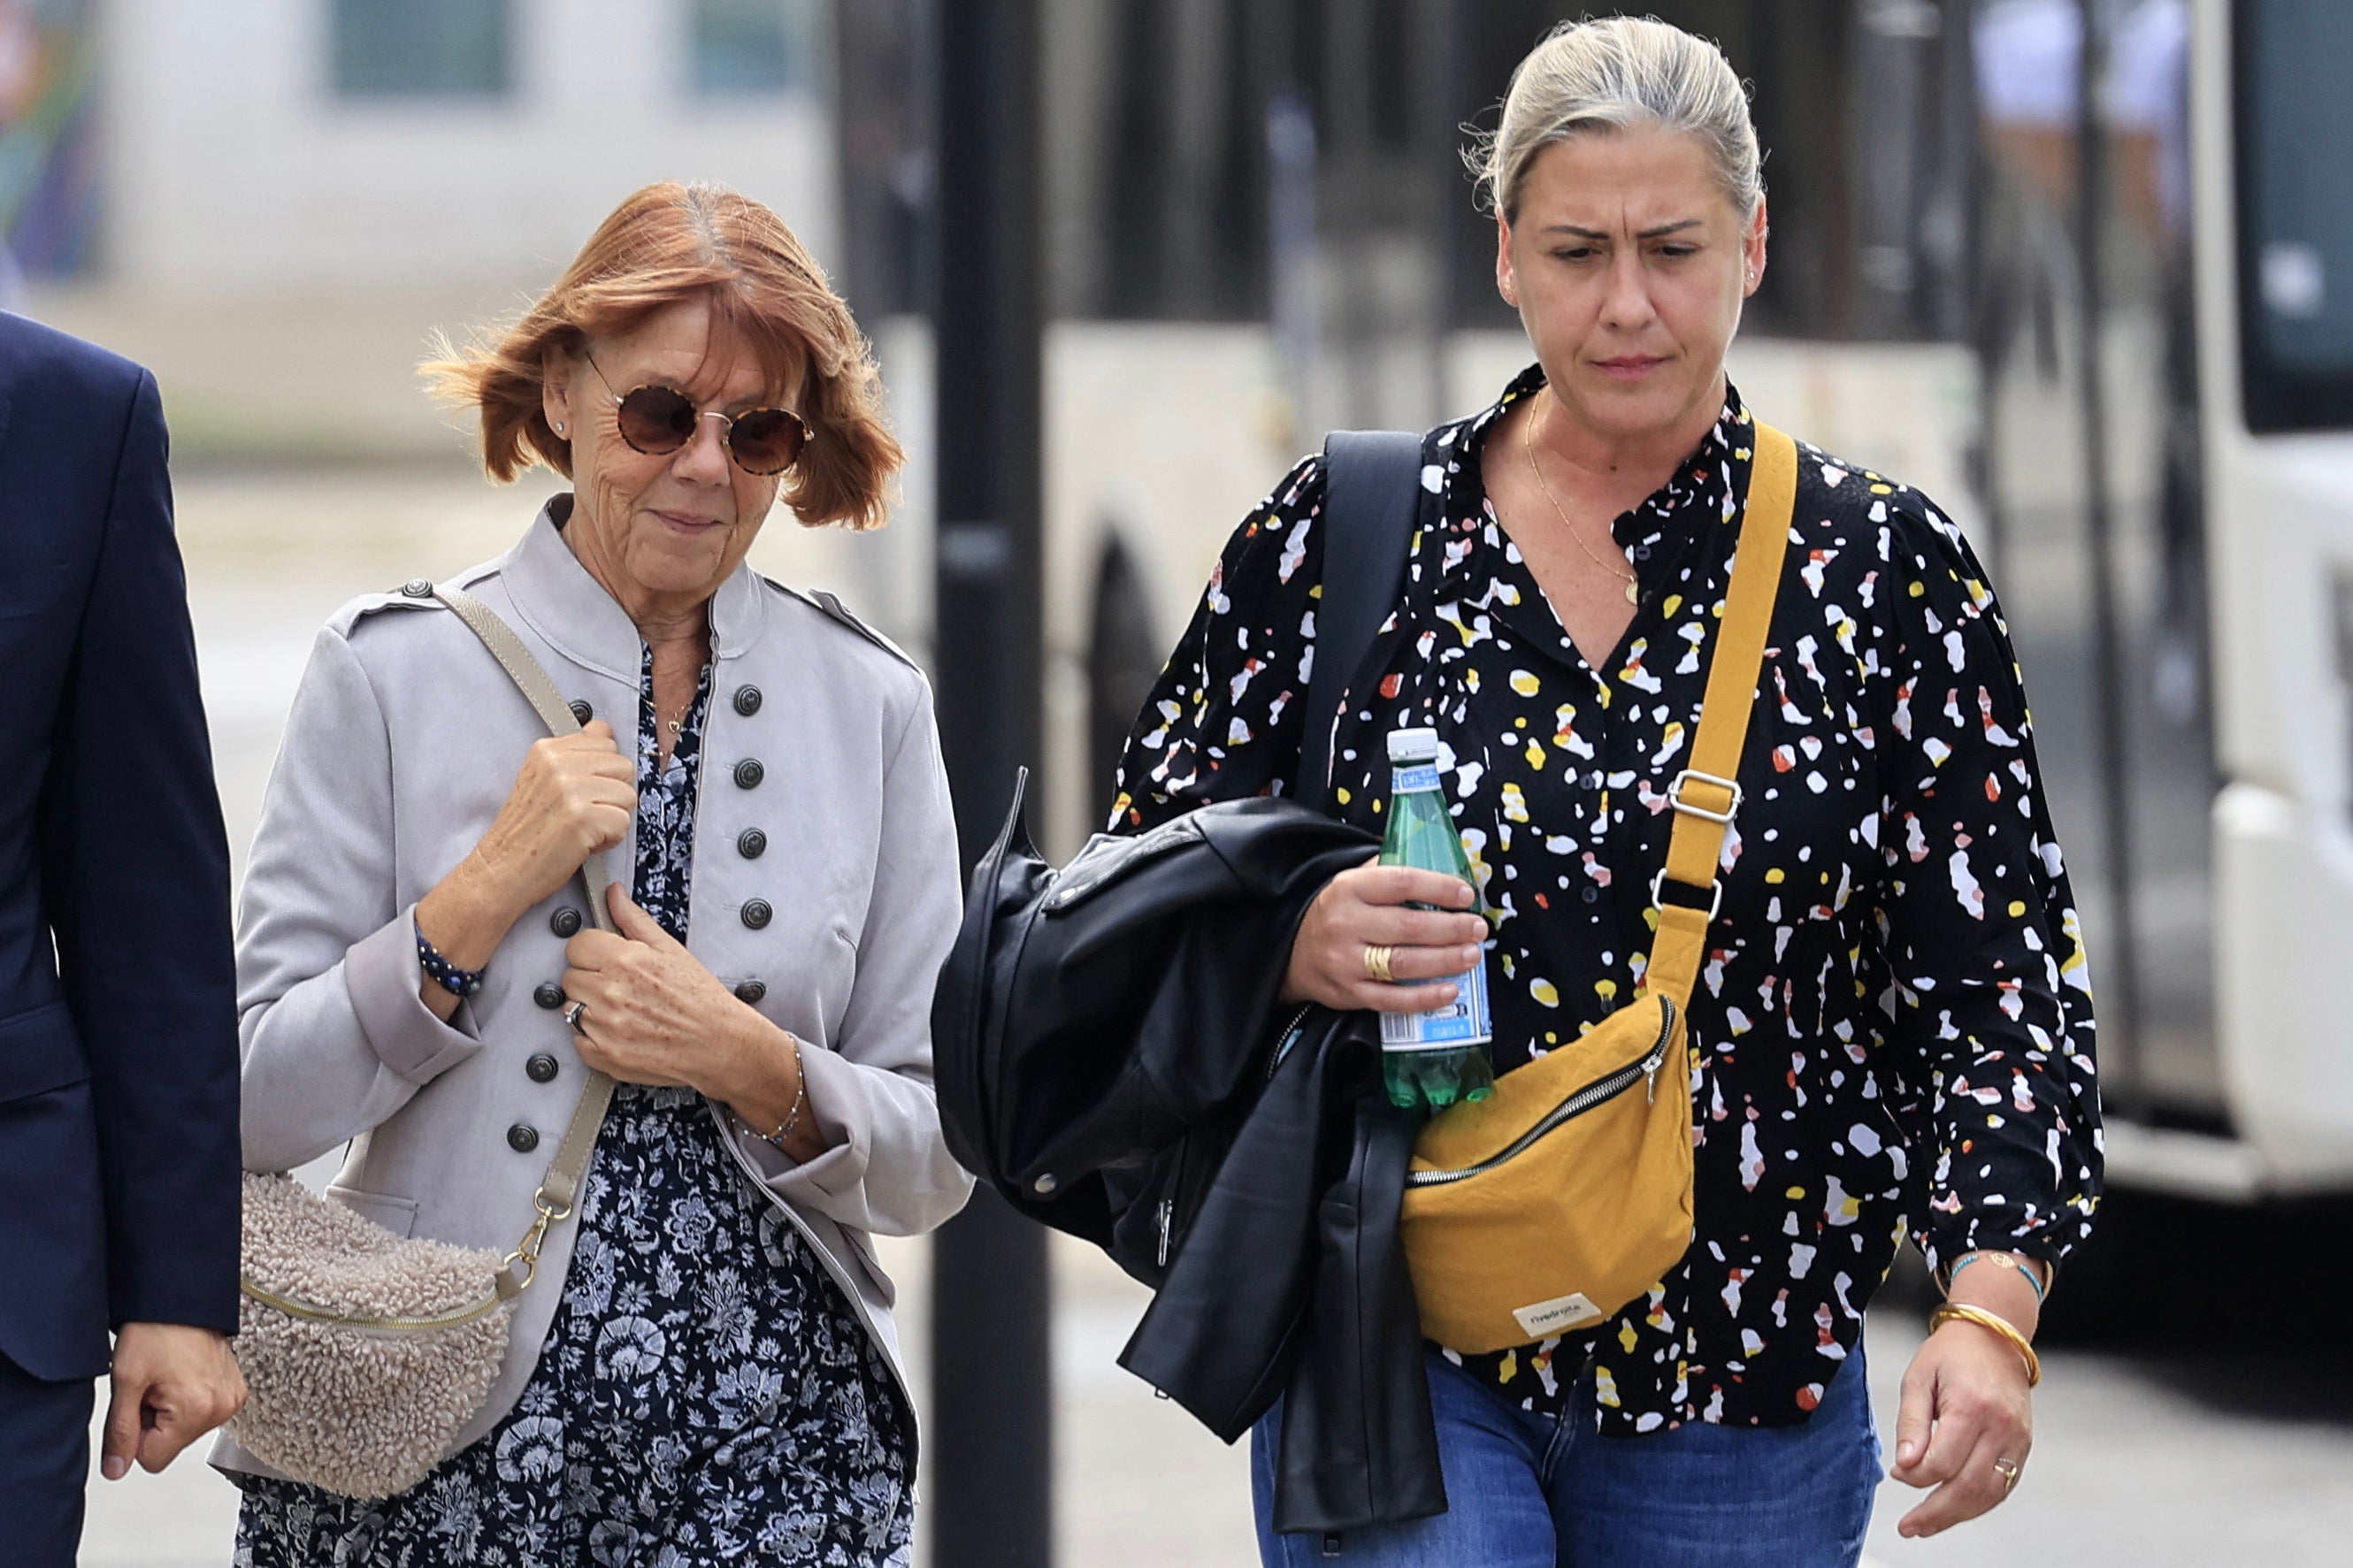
[217,186,970,1568]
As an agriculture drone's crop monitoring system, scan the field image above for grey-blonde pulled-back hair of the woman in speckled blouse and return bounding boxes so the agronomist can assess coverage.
[1464,17,1765,221]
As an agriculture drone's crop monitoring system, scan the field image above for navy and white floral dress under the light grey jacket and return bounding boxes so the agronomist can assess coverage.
[233,649,913,1568]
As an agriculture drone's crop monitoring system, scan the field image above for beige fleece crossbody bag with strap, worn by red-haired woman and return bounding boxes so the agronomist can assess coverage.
[228,588,612,1497]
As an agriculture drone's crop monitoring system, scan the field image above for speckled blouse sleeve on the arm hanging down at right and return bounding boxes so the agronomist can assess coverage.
[1847,486,2101,1267]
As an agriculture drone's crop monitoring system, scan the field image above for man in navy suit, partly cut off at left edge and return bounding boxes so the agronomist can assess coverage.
[0,313,245,1568]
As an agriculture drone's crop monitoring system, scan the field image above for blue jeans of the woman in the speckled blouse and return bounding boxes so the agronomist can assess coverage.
[1249,1344,1880,1568]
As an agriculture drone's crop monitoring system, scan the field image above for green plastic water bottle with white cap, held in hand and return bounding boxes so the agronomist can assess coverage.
[1381,729,1494,1110]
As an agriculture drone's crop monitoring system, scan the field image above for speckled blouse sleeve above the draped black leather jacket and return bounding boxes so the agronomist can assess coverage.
[1111,454,1325,832]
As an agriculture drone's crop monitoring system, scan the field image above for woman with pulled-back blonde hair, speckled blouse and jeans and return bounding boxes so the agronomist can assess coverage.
[1113,19,2099,1568]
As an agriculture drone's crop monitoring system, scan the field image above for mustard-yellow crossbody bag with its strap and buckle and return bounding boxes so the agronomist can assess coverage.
[1400,425,1797,1354]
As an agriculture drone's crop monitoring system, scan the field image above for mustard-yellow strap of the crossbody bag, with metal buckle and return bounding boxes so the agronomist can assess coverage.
[1643,423,1797,1008]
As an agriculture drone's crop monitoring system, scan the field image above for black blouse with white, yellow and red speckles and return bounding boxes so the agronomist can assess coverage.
[1113,367,2099,1432]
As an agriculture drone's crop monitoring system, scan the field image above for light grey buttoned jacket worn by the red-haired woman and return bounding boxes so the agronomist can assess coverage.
[211,499,972,1474]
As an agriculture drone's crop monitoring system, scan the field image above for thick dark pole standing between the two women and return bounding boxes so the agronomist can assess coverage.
[927,0,1054,1568]
